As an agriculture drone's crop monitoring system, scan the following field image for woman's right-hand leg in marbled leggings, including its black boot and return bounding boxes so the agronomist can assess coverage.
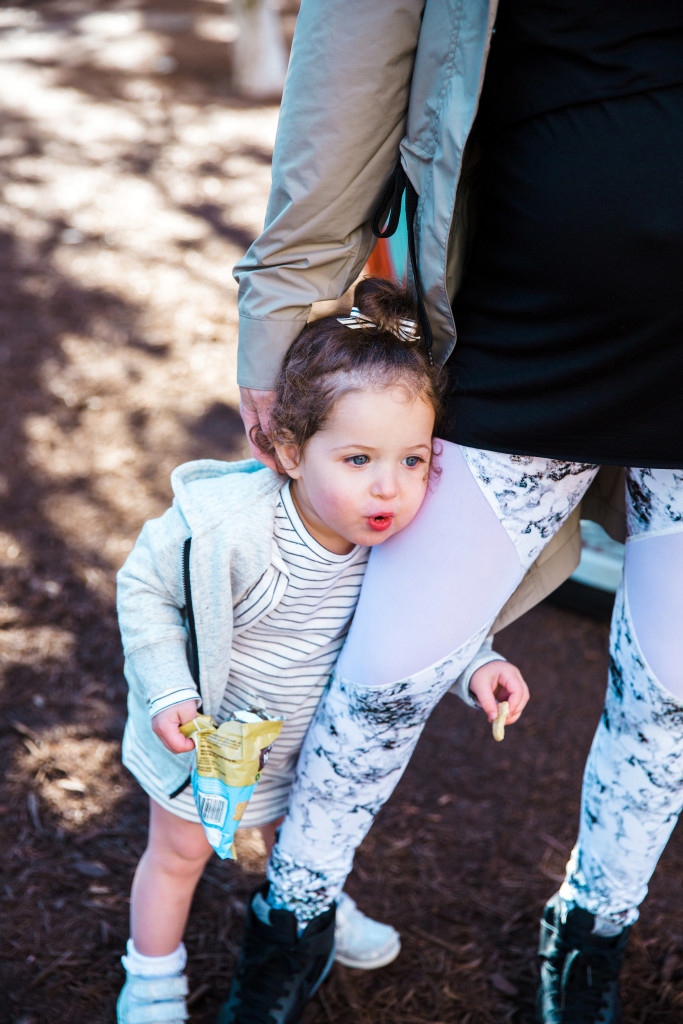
[538,469,683,1024]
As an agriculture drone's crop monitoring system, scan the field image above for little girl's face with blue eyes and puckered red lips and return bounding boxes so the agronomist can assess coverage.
[279,386,434,554]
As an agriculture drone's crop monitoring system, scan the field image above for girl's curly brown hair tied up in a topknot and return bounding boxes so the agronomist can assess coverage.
[251,278,444,455]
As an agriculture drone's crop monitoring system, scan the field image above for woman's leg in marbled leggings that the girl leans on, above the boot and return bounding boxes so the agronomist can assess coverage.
[268,443,597,921]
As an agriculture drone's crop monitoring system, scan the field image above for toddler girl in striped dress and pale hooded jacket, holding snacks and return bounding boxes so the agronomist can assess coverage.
[118,280,527,1024]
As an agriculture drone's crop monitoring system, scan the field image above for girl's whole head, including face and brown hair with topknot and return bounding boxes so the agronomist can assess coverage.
[256,279,442,552]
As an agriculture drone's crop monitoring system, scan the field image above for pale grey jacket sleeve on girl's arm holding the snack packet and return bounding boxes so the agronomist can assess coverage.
[117,508,199,715]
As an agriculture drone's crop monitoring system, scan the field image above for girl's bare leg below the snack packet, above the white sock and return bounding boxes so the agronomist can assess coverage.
[130,800,211,956]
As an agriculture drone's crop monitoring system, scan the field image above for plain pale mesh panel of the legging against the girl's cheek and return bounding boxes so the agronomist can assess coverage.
[339,442,522,685]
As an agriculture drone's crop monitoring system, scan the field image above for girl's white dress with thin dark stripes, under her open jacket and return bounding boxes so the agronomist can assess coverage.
[136,483,369,826]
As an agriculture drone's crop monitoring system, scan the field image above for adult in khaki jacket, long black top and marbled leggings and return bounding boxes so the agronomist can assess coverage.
[222,0,683,1024]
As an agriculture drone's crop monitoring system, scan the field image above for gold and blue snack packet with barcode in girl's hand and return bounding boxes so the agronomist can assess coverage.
[180,711,283,860]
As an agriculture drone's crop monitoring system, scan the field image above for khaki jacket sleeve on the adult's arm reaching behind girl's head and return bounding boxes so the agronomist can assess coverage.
[234,0,424,389]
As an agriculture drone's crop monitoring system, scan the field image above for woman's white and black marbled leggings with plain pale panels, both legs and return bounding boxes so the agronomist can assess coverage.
[268,443,683,926]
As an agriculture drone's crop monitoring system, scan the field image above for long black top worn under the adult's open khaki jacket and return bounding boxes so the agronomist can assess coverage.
[443,0,683,468]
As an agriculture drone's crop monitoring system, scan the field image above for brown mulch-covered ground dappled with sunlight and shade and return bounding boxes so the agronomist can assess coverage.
[0,0,683,1024]
